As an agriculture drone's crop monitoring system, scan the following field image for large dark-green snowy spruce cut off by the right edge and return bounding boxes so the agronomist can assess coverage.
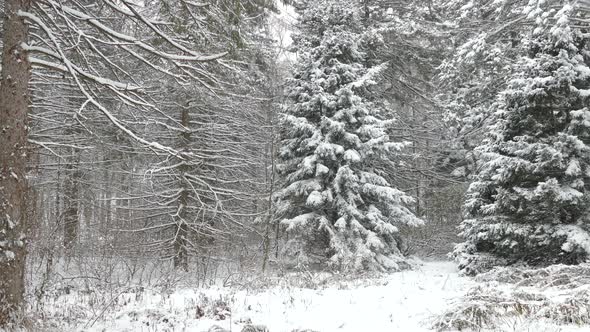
[454,5,590,273]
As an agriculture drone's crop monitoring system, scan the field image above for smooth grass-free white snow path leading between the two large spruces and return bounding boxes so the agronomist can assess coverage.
[248,262,472,332]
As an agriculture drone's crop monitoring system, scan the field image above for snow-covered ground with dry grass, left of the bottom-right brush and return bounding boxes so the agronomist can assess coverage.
[34,262,473,332]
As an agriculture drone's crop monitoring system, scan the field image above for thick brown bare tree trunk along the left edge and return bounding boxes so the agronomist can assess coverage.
[0,0,31,330]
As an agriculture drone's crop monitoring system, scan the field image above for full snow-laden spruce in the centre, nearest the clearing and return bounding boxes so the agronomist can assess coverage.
[277,0,421,270]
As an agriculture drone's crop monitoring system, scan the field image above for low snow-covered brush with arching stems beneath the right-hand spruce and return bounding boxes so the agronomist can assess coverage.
[435,264,590,331]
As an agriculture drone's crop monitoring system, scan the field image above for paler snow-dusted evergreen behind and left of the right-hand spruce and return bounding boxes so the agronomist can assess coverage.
[435,0,530,182]
